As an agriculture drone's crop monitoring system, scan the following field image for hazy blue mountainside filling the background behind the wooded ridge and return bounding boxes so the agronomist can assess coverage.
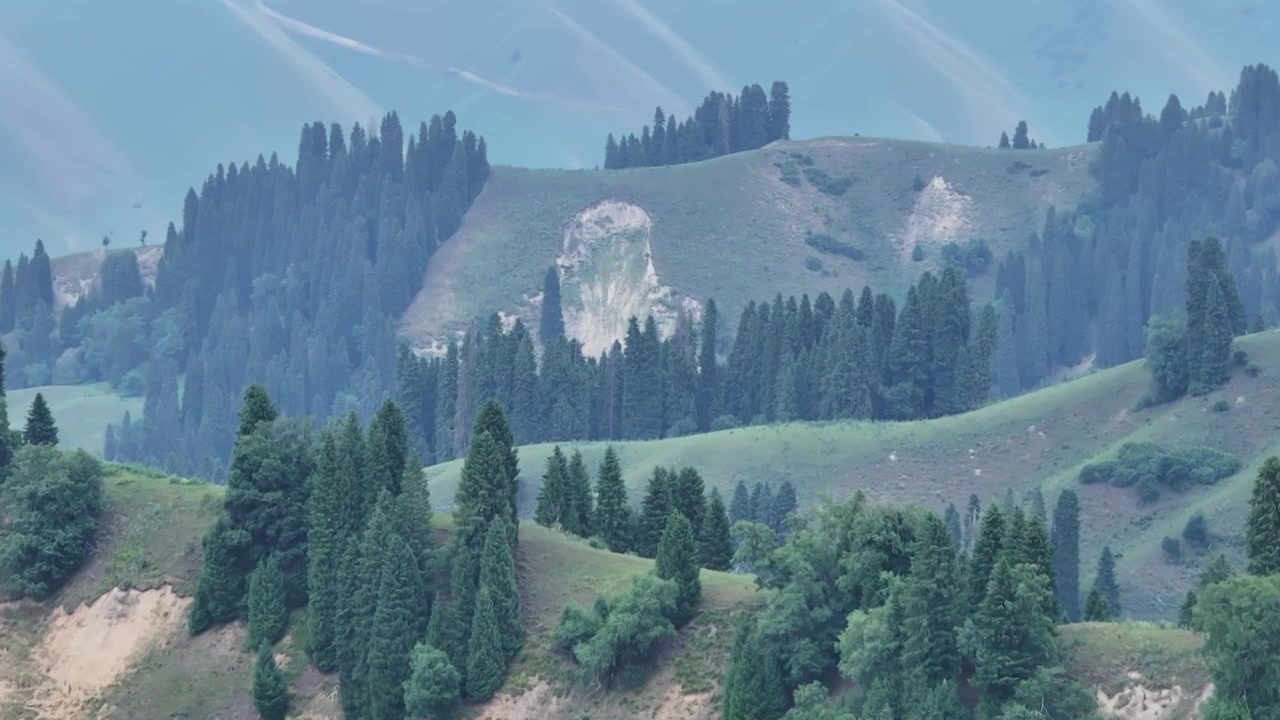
[0,0,1276,255]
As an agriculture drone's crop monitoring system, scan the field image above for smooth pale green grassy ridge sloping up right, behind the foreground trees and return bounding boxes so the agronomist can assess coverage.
[428,332,1280,616]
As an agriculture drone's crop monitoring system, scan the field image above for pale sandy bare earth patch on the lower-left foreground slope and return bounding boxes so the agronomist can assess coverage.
[32,587,191,717]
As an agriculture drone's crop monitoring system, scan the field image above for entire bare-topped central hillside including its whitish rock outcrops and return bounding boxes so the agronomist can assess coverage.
[401,137,1096,354]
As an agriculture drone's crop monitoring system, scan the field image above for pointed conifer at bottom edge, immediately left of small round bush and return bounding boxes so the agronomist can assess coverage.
[367,534,426,720]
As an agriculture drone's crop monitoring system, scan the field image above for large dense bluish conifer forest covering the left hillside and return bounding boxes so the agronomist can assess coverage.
[92,113,489,479]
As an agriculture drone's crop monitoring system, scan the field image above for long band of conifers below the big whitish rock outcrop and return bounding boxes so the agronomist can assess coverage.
[398,266,998,462]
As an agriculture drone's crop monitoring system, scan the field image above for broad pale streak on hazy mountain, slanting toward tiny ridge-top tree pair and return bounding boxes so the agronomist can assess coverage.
[878,0,1023,141]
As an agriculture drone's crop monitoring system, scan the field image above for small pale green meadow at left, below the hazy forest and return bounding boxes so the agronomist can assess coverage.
[8,383,142,455]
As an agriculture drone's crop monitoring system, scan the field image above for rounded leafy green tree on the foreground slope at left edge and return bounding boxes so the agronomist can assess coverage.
[0,445,102,598]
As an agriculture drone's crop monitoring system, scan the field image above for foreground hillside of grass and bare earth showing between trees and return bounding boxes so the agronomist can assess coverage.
[0,466,1207,720]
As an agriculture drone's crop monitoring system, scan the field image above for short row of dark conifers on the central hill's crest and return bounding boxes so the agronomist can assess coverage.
[604,81,791,170]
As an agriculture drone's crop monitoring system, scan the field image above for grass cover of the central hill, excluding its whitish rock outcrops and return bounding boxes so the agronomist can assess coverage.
[402,137,1093,342]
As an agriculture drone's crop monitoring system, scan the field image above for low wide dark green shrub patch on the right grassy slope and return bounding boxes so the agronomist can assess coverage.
[1079,442,1240,502]
